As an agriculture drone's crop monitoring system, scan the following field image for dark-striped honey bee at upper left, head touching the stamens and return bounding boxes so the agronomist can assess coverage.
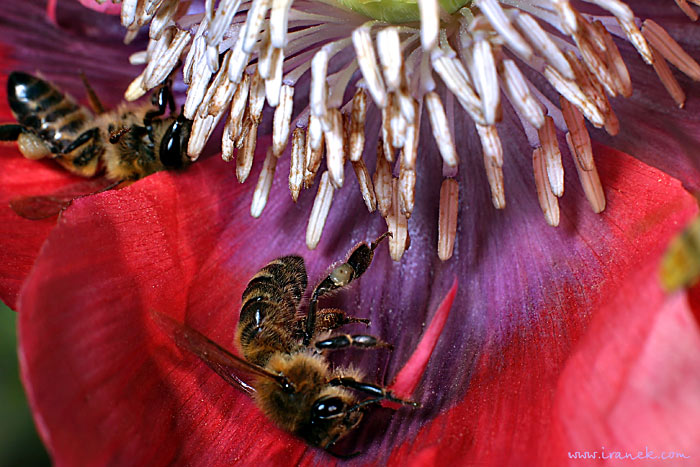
[0,71,192,218]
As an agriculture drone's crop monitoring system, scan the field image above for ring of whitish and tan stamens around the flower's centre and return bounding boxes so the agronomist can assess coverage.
[122,0,700,261]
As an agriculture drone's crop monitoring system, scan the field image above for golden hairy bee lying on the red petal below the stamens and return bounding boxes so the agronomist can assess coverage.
[155,233,418,450]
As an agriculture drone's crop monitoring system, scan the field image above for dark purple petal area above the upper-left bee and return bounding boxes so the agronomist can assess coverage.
[0,0,145,99]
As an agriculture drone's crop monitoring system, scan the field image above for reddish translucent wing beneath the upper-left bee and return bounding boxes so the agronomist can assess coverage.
[10,178,119,221]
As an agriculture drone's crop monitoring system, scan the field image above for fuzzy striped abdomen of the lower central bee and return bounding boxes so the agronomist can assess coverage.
[237,256,307,366]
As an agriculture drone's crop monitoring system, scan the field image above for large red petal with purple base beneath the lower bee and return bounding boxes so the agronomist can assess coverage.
[19,144,698,464]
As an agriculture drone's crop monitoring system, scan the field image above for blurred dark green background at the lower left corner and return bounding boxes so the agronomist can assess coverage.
[0,302,51,467]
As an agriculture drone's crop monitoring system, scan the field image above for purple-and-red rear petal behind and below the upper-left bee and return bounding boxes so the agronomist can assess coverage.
[0,0,149,309]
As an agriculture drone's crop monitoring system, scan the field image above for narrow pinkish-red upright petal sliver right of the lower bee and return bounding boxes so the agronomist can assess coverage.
[389,277,458,398]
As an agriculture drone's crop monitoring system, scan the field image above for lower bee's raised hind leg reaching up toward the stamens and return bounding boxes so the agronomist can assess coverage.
[304,232,391,346]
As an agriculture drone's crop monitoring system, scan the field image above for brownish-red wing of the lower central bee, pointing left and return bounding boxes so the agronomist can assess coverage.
[152,312,288,395]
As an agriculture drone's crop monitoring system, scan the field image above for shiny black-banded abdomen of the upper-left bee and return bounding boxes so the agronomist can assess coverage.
[7,71,89,153]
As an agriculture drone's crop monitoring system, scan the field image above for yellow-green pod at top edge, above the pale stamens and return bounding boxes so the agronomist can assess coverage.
[338,0,472,24]
